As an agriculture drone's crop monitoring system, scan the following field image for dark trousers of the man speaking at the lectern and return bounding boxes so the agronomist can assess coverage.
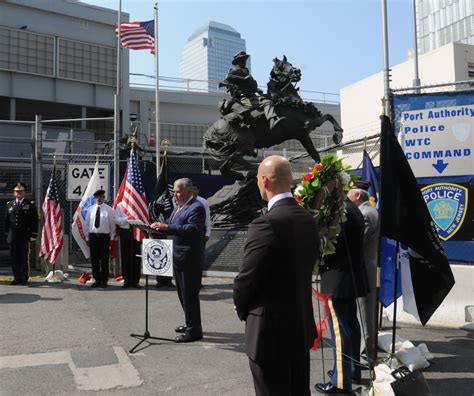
[173,265,202,337]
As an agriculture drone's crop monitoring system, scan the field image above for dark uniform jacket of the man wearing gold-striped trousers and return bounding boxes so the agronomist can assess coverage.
[321,199,368,299]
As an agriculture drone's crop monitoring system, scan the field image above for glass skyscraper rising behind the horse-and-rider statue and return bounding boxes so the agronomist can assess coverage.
[179,21,244,92]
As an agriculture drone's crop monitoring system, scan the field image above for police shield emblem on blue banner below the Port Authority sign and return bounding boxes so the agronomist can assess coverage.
[421,183,468,241]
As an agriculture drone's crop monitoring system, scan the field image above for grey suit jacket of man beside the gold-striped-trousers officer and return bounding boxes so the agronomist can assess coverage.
[359,201,379,291]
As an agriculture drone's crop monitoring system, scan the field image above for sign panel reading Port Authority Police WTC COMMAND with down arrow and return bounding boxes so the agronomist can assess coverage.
[399,105,474,177]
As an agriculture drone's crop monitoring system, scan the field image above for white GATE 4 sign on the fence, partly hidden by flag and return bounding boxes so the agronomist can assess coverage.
[67,164,111,201]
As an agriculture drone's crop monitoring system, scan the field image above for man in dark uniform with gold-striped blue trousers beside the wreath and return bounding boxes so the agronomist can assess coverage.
[315,199,368,395]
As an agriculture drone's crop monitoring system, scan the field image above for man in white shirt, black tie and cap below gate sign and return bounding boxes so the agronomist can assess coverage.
[85,190,115,288]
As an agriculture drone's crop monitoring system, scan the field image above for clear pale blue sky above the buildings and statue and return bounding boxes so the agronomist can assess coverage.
[82,0,413,94]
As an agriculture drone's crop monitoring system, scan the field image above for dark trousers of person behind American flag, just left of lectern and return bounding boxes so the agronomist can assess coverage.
[120,228,141,285]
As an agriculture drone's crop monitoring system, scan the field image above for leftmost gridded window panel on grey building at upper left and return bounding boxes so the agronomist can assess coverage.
[0,27,54,77]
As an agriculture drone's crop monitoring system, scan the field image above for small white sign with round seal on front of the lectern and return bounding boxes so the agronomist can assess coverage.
[142,239,173,277]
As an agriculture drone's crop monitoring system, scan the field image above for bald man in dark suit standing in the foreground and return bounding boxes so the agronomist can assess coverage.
[234,155,319,396]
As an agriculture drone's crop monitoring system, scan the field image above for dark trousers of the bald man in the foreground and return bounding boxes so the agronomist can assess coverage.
[249,350,311,396]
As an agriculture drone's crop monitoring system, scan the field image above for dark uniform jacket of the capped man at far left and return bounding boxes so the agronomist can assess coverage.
[5,198,38,243]
